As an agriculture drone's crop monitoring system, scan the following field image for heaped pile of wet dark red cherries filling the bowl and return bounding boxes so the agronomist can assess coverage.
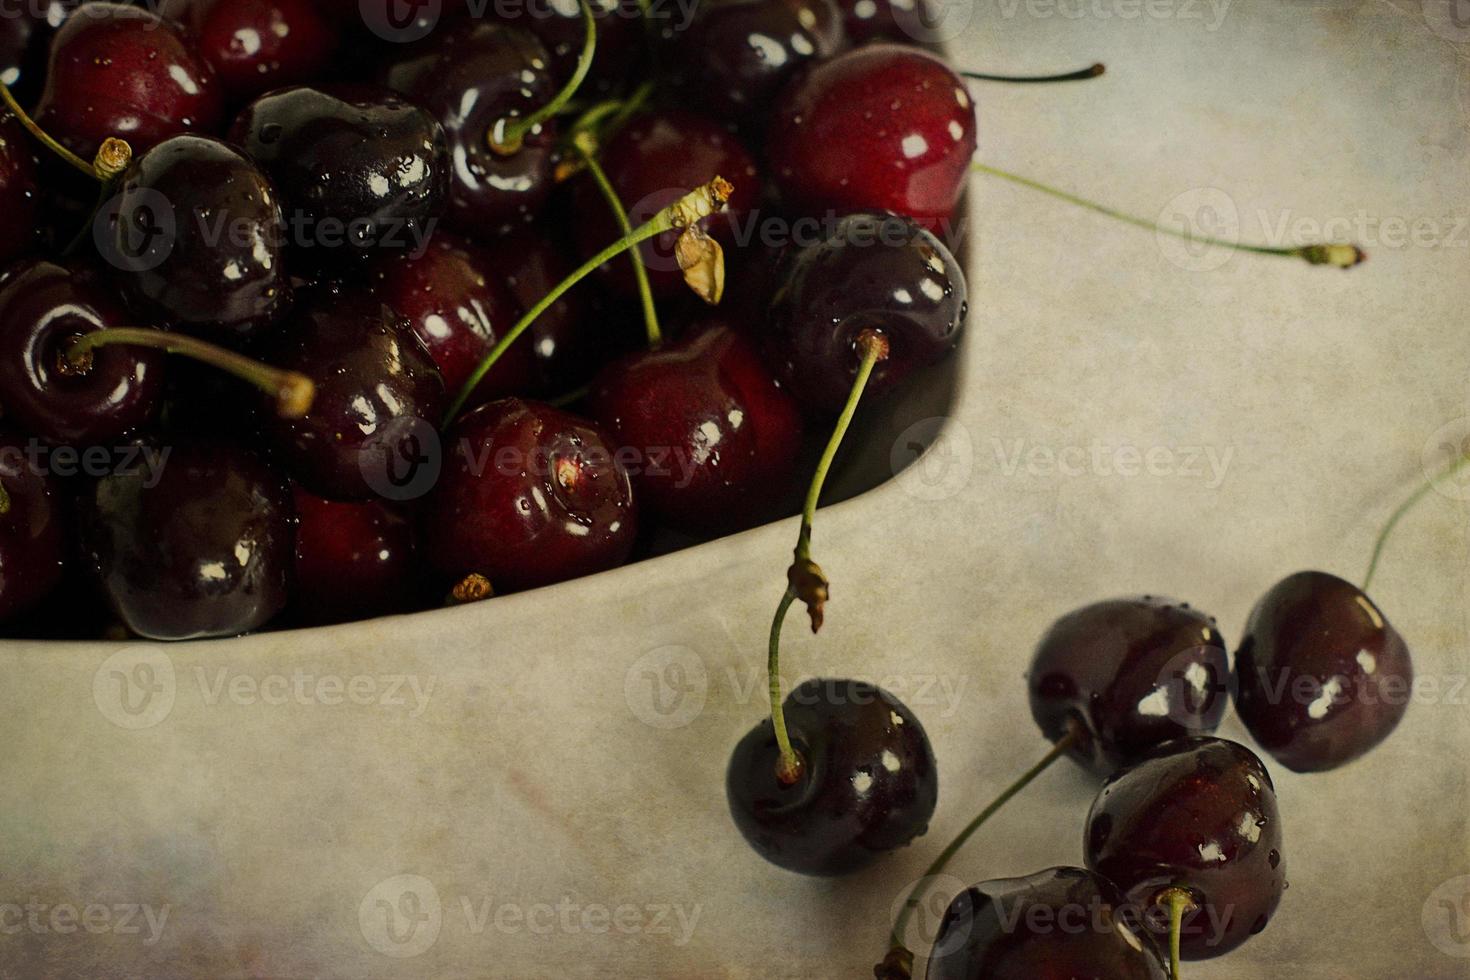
[0,0,976,641]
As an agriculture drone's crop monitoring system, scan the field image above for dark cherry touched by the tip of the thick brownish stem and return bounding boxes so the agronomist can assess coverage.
[265,285,445,501]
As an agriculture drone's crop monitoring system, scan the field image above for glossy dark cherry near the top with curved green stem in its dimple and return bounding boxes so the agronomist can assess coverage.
[387,21,557,238]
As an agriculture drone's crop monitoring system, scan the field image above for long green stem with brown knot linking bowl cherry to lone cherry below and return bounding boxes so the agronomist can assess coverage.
[766,329,888,786]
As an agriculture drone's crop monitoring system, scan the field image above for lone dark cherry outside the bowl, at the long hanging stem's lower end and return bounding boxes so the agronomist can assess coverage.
[725,679,939,876]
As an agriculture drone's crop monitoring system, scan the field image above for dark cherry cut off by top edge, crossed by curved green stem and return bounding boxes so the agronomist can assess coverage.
[485,0,645,93]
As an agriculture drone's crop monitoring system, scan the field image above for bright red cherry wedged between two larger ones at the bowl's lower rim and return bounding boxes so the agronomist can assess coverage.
[291,486,416,623]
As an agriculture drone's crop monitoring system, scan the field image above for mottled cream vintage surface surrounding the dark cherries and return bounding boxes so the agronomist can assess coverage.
[0,0,1470,980]
